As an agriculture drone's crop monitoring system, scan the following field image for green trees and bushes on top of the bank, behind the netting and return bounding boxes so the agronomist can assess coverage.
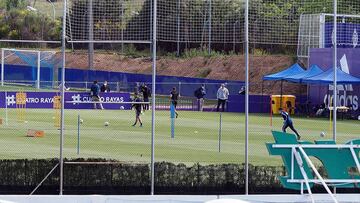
[0,0,360,54]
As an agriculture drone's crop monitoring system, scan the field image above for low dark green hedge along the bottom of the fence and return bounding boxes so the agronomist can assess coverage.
[0,159,330,194]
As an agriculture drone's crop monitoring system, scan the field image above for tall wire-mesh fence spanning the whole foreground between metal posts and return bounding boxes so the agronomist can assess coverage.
[0,0,360,197]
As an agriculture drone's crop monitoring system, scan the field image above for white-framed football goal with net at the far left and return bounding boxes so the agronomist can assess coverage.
[1,48,58,89]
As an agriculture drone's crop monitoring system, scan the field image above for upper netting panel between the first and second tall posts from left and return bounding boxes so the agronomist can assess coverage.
[66,0,151,43]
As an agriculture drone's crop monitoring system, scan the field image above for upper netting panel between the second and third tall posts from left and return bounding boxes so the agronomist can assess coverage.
[158,0,244,43]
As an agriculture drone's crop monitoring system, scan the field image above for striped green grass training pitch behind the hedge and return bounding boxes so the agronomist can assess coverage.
[0,109,360,165]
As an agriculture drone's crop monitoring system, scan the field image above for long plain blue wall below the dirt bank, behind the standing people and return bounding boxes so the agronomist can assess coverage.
[4,65,244,99]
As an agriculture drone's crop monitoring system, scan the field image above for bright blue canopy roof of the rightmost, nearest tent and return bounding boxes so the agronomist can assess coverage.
[303,68,360,84]
